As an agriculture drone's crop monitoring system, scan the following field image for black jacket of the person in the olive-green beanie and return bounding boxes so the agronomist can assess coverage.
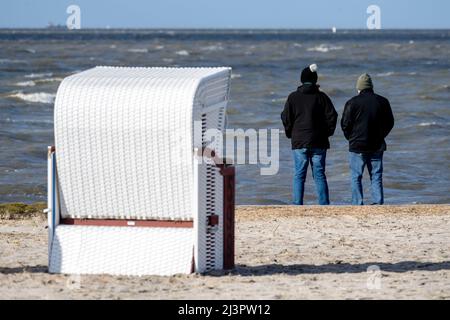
[341,89,394,153]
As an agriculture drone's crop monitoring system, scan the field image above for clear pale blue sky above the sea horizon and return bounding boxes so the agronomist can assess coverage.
[0,0,450,29]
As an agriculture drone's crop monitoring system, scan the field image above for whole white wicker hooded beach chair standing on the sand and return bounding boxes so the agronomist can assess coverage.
[48,67,234,275]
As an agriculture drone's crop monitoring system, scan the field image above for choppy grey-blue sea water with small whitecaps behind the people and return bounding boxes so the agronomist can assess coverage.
[0,30,450,204]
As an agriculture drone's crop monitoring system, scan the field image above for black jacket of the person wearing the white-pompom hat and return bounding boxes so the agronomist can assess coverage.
[281,85,337,150]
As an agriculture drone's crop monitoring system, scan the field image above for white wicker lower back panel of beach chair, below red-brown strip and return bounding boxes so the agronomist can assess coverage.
[49,225,194,276]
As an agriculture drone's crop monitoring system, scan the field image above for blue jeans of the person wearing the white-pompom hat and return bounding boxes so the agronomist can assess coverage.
[293,149,330,205]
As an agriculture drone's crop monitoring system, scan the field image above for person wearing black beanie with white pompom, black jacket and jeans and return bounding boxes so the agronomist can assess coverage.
[281,64,337,205]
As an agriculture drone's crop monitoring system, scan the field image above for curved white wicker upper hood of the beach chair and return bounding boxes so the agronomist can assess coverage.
[55,67,231,220]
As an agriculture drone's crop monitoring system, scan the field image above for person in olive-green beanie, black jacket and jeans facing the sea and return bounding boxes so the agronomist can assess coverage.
[341,74,394,205]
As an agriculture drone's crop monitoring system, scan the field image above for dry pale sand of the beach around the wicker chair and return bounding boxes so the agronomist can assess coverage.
[0,205,450,299]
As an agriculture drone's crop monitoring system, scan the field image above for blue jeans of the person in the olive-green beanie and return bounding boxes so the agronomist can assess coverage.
[350,152,384,206]
